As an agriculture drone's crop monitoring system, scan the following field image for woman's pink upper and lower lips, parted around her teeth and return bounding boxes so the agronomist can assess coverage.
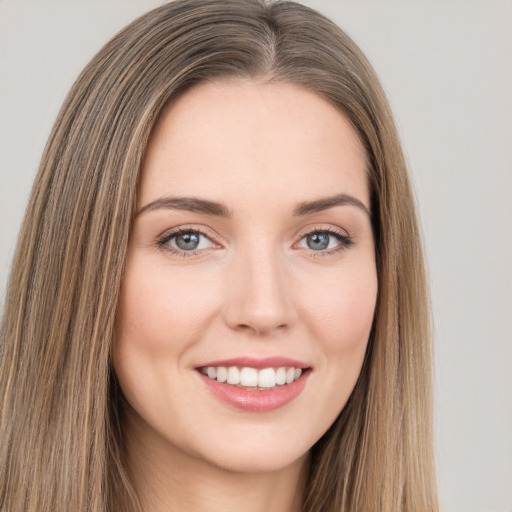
[197,357,311,412]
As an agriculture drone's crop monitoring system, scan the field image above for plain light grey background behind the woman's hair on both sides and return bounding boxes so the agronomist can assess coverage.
[0,0,512,512]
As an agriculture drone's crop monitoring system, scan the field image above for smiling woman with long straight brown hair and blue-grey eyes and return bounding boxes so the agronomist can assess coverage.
[0,0,437,512]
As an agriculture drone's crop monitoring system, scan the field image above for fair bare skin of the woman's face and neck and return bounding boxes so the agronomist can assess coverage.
[113,80,378,512]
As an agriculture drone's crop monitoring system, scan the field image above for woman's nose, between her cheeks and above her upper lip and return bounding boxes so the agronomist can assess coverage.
[223,245,296,336]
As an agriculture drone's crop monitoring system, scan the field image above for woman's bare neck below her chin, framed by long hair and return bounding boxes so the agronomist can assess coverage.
[126,412,309,512]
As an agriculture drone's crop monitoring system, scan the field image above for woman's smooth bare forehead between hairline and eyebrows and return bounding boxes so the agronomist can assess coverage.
[139,80,369,207]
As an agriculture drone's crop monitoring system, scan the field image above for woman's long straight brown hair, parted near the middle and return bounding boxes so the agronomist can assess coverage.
[0,0,437,512]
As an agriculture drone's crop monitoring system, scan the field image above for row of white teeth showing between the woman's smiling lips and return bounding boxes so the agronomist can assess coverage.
[200,366,302,389]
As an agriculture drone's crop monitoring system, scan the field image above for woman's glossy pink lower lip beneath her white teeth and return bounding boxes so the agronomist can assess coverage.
[199,371,311,412]
